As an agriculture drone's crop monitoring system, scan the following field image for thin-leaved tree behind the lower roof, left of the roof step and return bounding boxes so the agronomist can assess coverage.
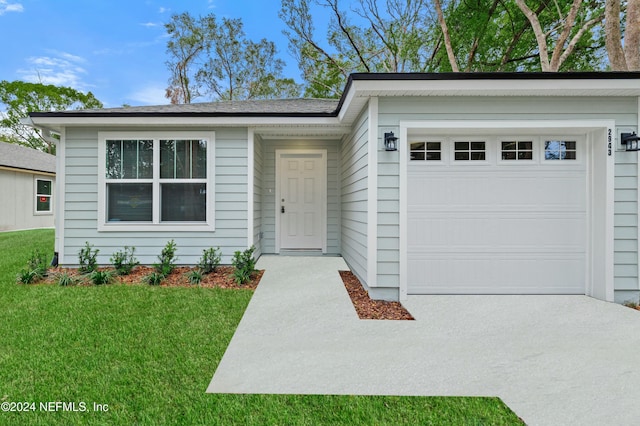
[165,13,300,103]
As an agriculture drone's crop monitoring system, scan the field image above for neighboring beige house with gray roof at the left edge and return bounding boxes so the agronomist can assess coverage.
[0,142,56,231]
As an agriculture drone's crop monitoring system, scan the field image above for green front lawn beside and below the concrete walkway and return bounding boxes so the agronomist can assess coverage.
[0,230,522,425]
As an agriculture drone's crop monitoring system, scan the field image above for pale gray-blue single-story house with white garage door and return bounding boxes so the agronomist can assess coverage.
[30,72,640,302]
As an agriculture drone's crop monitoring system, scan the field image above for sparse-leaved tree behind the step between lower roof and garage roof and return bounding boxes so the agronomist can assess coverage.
[280,0,432,98]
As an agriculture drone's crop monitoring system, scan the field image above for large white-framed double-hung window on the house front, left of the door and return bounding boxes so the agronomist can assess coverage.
[98,132,214,231]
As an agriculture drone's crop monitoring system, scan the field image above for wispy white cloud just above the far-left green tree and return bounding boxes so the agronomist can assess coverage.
[18,51,87,90]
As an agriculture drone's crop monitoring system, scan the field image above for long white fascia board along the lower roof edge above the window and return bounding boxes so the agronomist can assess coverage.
[31,116,340,129]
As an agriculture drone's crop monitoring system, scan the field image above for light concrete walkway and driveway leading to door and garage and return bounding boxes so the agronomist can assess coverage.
[207,256,640,425]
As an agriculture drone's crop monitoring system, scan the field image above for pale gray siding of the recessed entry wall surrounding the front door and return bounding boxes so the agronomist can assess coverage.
[261,139,340,254]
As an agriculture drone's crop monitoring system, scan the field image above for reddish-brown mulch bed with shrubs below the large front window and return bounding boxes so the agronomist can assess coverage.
[45,266,264,290]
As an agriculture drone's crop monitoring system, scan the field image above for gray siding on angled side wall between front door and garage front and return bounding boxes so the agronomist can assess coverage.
[340,109,369,285]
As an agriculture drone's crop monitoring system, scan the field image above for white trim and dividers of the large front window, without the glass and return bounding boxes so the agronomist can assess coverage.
[98,131,215,232]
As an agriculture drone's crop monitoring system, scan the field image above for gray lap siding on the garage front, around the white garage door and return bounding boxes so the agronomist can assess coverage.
[378,97,638,301]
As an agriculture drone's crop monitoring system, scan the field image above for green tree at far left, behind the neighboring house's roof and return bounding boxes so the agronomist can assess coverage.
[0,80,103,154]
